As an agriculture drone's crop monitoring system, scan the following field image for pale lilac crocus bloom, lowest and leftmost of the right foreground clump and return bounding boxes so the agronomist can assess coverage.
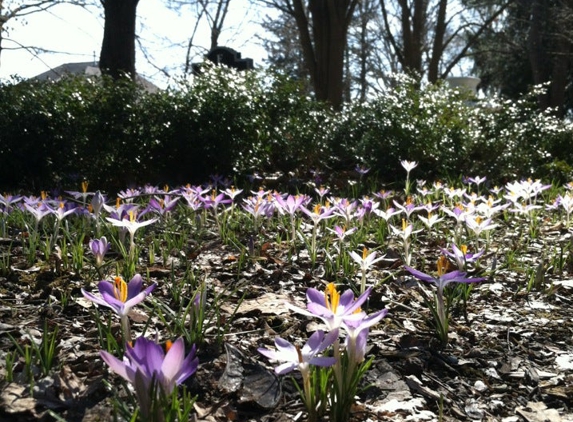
[257,330,338,375]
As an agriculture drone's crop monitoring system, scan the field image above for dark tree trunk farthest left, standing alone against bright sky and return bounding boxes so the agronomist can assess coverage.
[99,0,139,79]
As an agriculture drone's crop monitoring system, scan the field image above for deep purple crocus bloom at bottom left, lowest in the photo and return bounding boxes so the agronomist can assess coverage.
[100,337,199,420]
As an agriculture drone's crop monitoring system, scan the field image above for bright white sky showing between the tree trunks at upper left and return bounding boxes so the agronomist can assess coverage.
[0,0,270,88]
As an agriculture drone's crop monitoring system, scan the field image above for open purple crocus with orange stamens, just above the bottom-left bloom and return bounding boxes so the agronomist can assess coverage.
[82,274,157,317]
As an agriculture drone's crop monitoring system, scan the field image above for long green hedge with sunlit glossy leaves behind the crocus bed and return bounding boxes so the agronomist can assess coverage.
[0,66,573,195]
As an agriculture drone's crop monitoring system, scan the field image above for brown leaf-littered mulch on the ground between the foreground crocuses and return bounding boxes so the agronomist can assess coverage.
[0,216,573,422]
